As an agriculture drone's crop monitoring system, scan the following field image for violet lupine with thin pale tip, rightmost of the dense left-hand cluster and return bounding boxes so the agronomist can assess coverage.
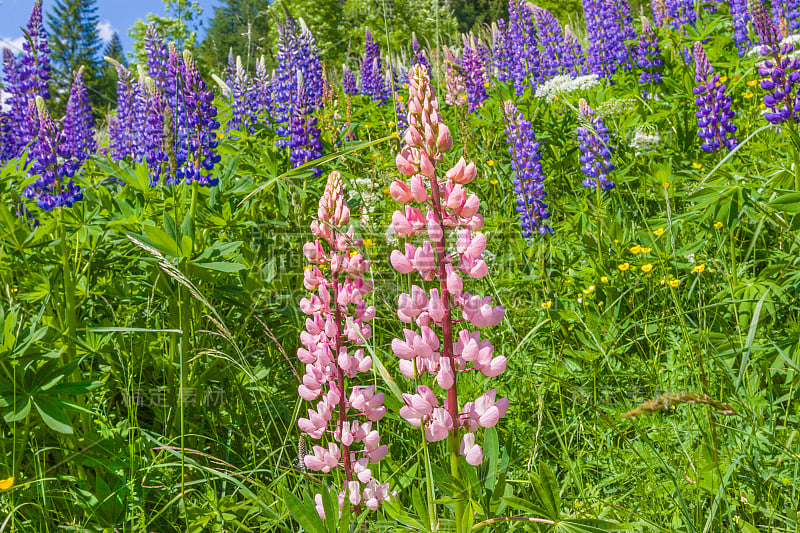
[176,51,221,187]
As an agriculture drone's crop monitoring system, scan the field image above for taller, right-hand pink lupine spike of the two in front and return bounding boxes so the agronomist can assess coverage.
[389,65,508,470]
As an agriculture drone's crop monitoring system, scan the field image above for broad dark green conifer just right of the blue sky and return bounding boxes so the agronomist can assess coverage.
[200,0,272,71]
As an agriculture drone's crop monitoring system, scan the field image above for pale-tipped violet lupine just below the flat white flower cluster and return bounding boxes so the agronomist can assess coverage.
[578,98,614,191]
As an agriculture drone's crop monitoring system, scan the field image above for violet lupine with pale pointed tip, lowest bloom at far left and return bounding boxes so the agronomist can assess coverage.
[22,96,83,211]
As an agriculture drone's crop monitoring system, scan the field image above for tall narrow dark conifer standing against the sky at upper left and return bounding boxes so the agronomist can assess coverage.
[47,0,102,103]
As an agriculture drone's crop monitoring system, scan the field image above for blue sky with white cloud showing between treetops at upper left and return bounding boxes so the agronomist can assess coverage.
[0,0,221,57]
